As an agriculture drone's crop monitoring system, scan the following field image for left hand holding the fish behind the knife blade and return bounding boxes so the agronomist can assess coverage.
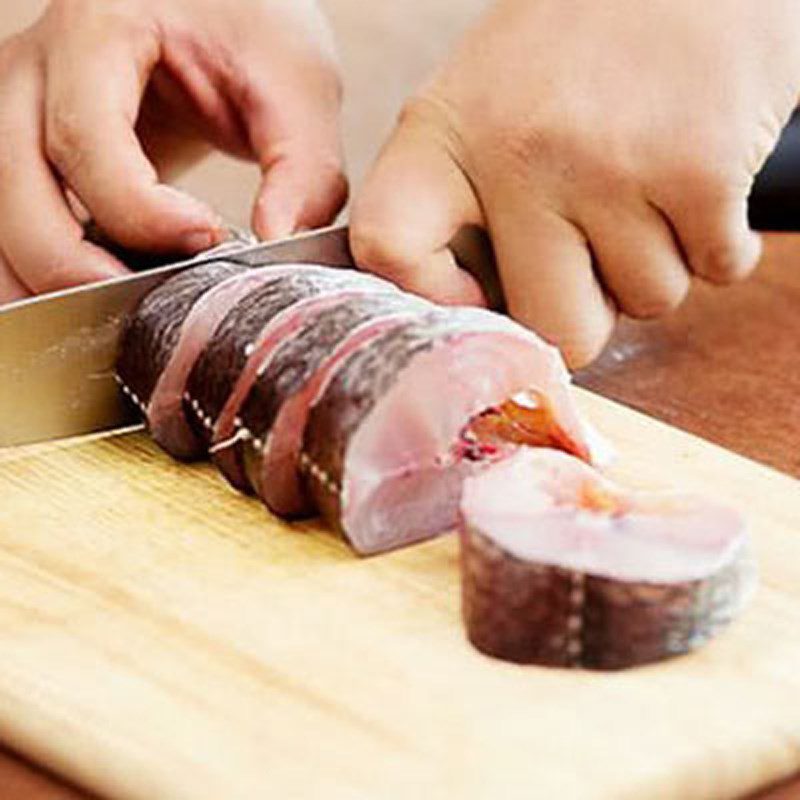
[0,0,346,303]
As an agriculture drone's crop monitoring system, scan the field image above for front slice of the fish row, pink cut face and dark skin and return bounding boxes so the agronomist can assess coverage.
[303,308,588,554]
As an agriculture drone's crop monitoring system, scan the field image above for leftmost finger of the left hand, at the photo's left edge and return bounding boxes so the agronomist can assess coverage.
[0,61,126,299]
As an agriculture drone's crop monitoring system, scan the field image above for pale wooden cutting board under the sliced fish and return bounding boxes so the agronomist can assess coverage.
[0,392,800,800]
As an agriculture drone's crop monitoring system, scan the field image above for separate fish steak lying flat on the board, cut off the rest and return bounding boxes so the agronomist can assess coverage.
[460,448,755,669]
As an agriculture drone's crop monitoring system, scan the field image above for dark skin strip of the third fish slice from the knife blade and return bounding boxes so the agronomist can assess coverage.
[240,290,423,514]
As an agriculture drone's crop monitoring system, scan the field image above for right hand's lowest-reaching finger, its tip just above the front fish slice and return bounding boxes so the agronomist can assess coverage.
[486,192,616,368]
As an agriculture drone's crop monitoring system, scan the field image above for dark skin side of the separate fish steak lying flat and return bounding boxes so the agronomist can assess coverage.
[460,524,755,670]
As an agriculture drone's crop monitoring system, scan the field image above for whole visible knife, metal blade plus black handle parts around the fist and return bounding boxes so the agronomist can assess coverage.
[0,112,800,448]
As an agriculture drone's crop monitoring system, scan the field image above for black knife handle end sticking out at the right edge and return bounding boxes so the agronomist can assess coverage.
[749,113,800,231]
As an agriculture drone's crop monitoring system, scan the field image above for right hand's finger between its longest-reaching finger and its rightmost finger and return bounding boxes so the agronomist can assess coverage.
[581,200,691,319]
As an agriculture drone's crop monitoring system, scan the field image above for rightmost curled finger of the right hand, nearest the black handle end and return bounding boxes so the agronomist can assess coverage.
[658,179,762,284]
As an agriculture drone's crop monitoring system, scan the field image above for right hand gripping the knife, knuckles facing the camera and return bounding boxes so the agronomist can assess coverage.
[352,0,800,366]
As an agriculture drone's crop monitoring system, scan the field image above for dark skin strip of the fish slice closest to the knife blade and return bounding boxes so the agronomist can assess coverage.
[117,261,247,411]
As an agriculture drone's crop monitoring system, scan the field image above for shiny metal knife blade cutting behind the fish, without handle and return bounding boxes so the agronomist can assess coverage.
[0,226,353,447]
